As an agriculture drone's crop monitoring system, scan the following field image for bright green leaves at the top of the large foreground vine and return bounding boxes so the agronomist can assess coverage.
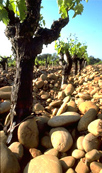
[0,0,88,25]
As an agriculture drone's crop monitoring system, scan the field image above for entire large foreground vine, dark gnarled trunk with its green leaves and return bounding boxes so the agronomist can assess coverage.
[0,0,88,135]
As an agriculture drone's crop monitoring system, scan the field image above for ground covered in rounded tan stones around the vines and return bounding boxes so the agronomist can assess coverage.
[0,65,102,173]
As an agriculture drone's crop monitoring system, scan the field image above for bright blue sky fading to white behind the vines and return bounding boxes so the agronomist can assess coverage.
[0,0,102,60]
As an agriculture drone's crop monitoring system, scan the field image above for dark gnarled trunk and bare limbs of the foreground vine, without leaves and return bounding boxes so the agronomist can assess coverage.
[5,0,69,133]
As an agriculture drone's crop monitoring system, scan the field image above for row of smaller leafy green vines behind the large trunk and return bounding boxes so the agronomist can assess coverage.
[55,34,88,84]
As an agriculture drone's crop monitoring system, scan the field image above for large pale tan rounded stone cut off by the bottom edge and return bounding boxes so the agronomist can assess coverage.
[23,154,62,173]
